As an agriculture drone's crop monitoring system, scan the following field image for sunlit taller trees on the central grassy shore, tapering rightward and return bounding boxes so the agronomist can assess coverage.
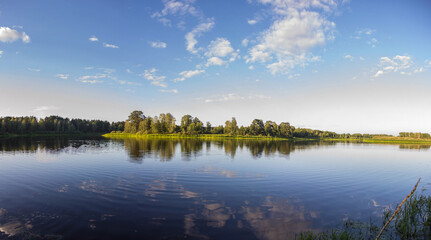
[120,111,416,139]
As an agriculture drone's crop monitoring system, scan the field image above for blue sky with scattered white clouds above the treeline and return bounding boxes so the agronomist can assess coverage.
[0,0,431,134]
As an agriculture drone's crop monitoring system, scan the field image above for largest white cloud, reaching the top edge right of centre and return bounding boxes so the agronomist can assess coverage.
[246,0,336,74]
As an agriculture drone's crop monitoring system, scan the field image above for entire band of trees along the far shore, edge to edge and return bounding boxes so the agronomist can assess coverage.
[0,111,431,139]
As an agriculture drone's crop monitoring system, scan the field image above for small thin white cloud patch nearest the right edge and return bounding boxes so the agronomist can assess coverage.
[374,55,425,78]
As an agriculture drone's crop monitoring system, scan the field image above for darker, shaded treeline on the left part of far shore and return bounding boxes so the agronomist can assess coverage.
[0,116,124,134]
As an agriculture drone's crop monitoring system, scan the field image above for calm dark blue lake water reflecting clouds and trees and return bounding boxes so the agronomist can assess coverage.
[0,138,431,240]
